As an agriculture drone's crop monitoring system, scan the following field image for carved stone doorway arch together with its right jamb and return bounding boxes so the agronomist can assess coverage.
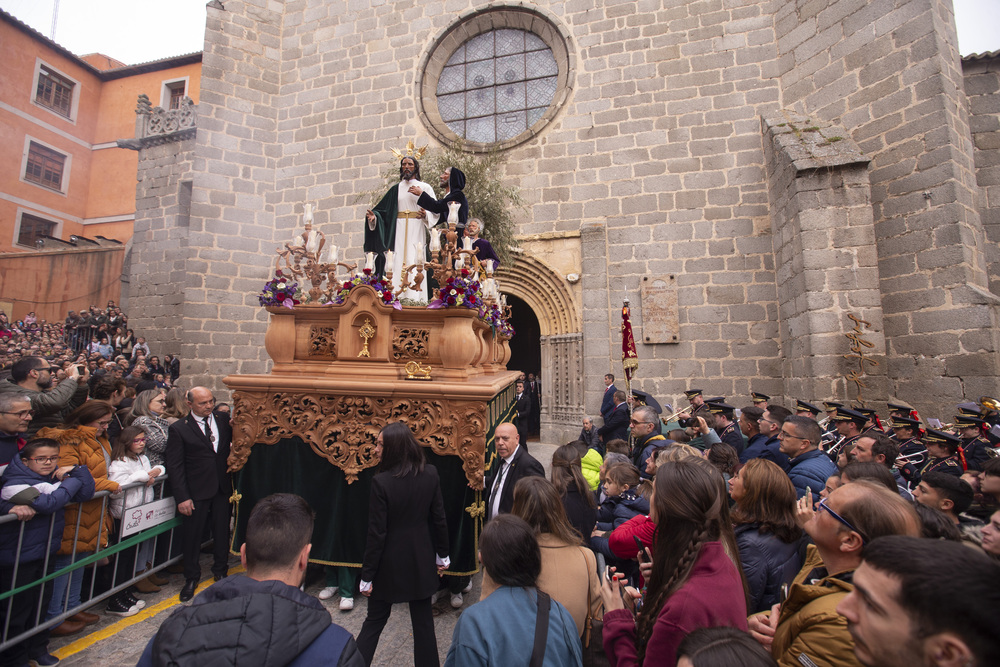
[498,251,584,443]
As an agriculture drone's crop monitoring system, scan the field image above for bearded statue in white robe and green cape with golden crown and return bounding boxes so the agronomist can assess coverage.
[364,157,439,301]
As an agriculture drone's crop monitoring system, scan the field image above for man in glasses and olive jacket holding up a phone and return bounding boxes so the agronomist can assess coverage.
[0,357,90,440]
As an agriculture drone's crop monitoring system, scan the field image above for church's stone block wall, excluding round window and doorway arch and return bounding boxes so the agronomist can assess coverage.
[127,0,1000,432]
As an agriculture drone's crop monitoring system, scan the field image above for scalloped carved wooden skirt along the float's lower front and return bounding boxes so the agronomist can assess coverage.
[229,391,489,490]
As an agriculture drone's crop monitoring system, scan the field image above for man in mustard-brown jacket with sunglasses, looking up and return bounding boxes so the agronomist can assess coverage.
[749,480,920,667]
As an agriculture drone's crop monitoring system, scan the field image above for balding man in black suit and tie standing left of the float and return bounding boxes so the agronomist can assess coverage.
[164,387,233,602]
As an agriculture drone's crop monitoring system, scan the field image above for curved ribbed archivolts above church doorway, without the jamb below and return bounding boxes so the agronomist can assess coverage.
[497,252,583,337]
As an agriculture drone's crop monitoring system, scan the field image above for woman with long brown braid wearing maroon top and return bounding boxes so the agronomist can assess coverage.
[601,459,747,667]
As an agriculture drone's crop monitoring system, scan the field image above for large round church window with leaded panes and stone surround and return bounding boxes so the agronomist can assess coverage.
[418,7,573,150]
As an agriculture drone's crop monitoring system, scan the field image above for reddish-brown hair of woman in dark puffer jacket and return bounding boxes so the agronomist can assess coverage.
[733,459,802,544]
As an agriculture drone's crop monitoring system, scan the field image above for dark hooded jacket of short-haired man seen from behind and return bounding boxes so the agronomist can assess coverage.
[137,576,365,667]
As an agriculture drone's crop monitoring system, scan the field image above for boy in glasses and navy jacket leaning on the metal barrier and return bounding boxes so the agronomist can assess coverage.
[0,438,94,665]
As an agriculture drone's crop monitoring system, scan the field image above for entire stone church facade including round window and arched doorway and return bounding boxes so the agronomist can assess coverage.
[130,0,1000,442]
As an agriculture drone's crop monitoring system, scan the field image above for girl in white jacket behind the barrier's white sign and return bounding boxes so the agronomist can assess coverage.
[108,426,165,607]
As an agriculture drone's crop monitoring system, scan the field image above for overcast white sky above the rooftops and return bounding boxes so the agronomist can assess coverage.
[0,0,1000,65]
